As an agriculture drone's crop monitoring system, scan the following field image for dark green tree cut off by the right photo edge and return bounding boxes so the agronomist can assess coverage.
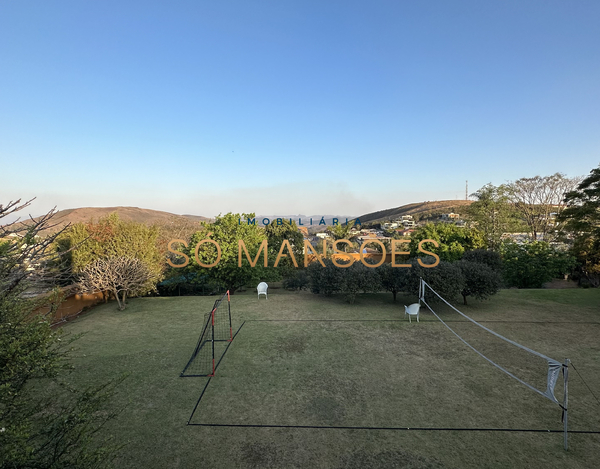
[559,166,600,287]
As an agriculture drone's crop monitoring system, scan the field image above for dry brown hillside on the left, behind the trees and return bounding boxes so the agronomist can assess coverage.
[27,207,210,232]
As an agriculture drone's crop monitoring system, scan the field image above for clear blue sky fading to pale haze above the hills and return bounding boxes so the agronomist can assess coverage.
[0,0,600,216]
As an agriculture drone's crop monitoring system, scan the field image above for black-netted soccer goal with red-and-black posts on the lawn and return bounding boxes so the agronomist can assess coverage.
[180,290,233,377]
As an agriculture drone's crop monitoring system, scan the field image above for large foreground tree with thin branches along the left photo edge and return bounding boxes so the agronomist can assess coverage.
[0,200,122,469]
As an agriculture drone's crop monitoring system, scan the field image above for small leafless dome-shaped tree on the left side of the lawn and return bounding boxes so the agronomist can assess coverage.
[79,257,157,310]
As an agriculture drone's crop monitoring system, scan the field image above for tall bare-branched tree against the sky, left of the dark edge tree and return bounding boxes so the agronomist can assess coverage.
[507,173,581,241]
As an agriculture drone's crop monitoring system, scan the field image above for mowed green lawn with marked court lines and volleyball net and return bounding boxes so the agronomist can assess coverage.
[64,289,600,469]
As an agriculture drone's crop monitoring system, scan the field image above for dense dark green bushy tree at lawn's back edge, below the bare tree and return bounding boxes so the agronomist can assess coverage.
[502,241,575,288]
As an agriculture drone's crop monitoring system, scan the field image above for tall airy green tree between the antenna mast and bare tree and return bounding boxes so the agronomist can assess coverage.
[467,184,519,251]
